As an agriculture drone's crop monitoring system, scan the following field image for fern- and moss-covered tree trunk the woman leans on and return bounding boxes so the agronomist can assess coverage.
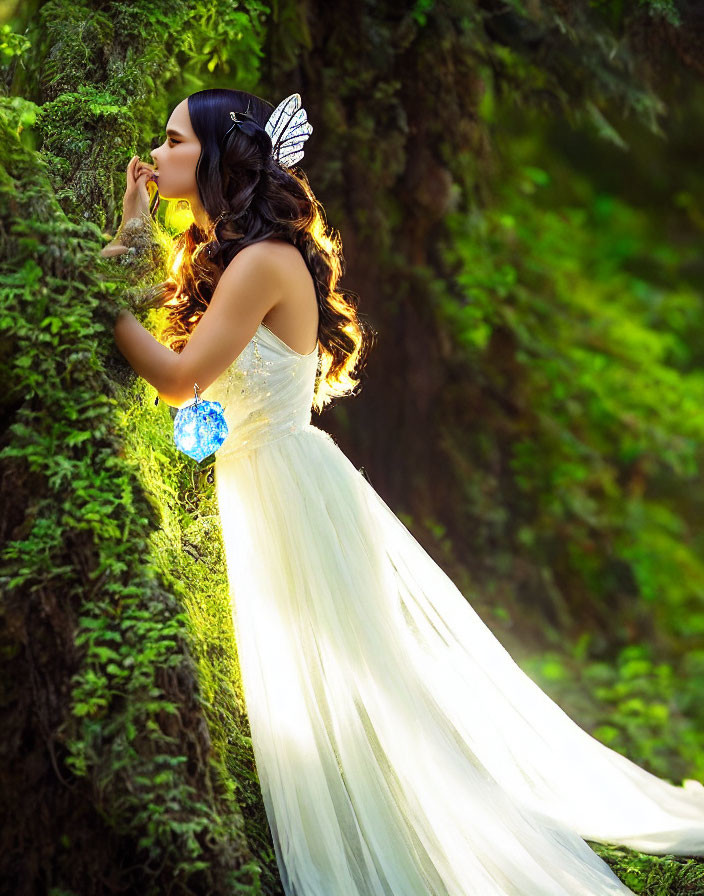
[0,2,280,896]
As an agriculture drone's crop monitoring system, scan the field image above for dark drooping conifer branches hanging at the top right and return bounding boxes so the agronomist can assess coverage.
[454,0,677,138]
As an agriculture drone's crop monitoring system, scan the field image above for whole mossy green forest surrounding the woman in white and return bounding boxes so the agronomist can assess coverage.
[0,0,704,896]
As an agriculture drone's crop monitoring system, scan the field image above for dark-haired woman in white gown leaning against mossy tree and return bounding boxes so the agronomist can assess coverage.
[104,90,704,896]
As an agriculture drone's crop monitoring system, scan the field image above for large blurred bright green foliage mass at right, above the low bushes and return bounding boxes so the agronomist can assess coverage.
[434,100,704,643]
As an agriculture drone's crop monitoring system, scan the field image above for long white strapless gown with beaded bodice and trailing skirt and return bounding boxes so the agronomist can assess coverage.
[202,324,704,896]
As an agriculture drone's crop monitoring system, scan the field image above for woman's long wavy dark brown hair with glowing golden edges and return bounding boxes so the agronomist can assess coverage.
[149,88,376,412]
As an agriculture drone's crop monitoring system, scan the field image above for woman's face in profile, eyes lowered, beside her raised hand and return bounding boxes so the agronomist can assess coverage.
[151,100,201,207]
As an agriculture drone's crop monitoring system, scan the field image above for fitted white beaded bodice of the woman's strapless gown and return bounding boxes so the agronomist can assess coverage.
[200,323,319,461]
